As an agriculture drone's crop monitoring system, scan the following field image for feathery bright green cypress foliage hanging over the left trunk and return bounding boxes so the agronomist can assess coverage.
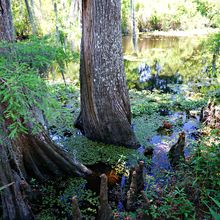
[0,39,75,138]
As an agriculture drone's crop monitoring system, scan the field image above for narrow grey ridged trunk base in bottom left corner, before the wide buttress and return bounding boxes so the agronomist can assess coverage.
[0,142,34,220]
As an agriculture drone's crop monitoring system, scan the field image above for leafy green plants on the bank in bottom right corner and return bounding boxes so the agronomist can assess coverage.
[164,130,220,219]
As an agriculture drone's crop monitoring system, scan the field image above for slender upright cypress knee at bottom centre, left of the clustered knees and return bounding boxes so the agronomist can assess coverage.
[97,174,113,220]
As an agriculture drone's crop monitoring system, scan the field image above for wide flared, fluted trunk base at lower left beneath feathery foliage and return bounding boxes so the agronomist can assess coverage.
[0,103,90,220]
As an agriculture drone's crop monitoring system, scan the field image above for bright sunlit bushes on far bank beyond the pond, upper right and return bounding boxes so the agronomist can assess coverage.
[122,0,220,32]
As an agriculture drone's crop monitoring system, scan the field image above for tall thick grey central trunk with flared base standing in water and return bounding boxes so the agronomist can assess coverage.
[75,0,138,148]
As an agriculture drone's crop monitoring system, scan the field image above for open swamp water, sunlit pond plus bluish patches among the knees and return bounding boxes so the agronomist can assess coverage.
[49,34,212,217]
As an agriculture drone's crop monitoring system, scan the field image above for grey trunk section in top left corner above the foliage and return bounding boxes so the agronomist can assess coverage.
[0,0,14,41]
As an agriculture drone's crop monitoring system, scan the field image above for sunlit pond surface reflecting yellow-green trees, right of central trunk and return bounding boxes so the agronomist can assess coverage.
[123,34,211,92]
